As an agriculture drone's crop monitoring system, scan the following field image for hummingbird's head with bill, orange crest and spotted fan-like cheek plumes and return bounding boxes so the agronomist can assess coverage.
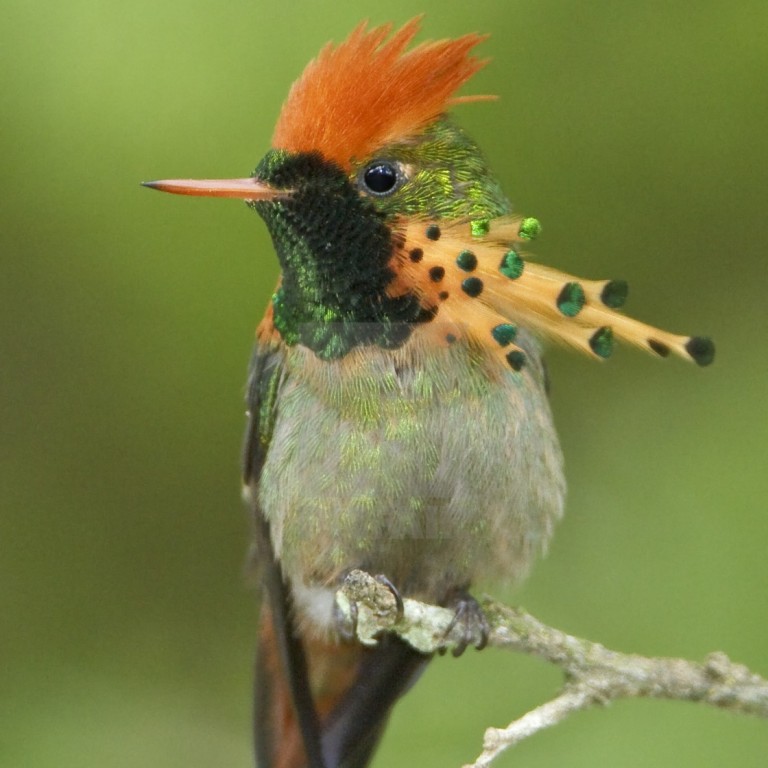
[148,19,713,370]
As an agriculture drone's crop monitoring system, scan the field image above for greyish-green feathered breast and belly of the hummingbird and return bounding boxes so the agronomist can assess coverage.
[259,334,564,632]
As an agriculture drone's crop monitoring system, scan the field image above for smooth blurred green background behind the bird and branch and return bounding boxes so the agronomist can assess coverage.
[0,0,768,768]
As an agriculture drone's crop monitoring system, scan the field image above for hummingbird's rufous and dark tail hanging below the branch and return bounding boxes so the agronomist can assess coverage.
[255,607,430,768]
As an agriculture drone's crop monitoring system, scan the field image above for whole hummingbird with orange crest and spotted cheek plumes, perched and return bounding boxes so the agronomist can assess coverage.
[146,18,714,768]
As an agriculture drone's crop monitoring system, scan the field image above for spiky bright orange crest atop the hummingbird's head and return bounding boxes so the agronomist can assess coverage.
[272,18,486,169]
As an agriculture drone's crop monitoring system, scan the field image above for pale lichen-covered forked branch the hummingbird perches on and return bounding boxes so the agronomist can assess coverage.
[336,571,768,768]
